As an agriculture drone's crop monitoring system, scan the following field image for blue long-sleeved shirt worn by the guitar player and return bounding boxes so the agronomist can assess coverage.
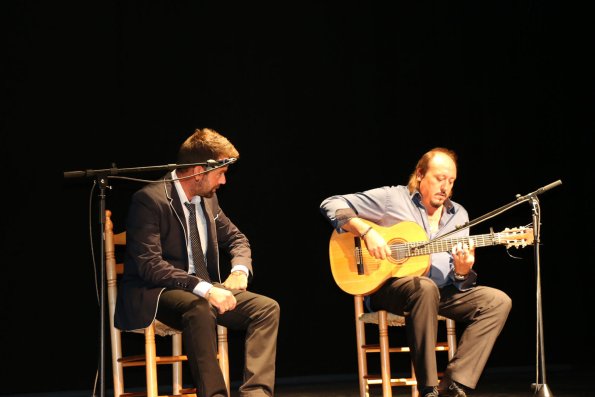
[320,185,475,290]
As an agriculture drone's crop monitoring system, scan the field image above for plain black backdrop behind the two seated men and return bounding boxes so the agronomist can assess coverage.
[0,0,594,394]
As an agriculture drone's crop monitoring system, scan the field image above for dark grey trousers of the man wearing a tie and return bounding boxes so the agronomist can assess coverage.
[157,290,280,397]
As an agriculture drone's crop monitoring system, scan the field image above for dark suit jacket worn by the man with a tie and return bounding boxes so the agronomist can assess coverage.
[115,174,252,330]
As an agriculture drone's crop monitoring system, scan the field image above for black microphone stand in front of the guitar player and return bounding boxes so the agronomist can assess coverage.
[424,180,562,397]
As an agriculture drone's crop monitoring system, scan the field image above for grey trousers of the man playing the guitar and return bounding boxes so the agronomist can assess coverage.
[370,276,512,390]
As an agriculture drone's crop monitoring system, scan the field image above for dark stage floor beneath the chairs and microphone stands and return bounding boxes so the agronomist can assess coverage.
[1,367,595,397]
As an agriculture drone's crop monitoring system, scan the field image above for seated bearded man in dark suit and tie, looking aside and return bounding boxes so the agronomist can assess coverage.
[115,128,280,397]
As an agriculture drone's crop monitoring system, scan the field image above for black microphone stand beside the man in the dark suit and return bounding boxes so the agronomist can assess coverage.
[64,159,226,397]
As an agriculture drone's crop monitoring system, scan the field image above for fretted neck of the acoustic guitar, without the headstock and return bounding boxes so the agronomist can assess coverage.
[391,234,500,259]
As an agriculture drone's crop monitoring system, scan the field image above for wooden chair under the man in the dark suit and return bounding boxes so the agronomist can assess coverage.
[104,210,230,397]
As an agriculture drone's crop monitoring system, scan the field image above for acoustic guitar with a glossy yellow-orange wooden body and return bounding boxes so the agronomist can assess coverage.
[329,220,533,295]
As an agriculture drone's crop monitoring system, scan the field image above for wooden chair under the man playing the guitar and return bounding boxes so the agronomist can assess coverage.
[354,295,457,397]
